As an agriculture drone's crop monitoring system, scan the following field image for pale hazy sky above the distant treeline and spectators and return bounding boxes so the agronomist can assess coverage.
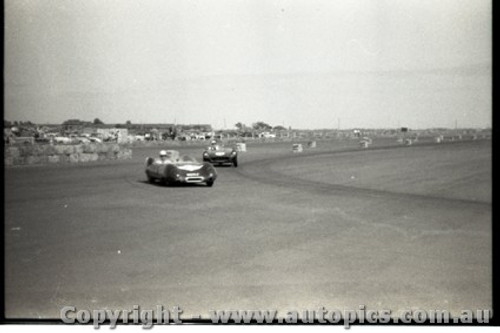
[4,0,492,129]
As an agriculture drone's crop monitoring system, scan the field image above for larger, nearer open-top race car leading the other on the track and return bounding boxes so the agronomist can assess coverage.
[146,150,217,187]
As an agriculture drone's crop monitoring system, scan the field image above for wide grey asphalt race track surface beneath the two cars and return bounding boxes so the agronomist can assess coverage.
[5,140,492,320]
